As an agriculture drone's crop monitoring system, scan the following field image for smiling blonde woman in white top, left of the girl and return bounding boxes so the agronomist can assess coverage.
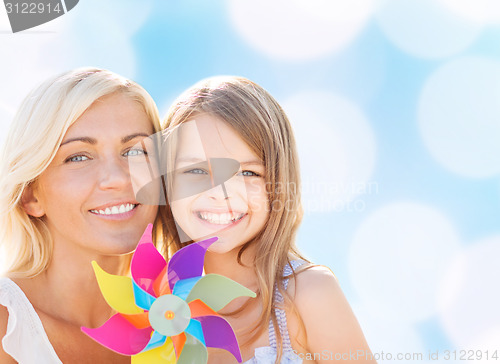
[0,68,160,364]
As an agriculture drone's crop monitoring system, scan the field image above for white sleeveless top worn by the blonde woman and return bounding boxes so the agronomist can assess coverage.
[0,278,62,364]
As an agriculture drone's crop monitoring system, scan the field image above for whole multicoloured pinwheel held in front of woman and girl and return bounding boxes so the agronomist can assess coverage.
[82,225,255,364]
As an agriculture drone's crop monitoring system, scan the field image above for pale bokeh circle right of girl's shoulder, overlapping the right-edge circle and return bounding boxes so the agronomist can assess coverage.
[349,202,460,323]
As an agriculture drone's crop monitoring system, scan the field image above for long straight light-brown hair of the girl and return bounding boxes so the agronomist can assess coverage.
[160,76,303,361]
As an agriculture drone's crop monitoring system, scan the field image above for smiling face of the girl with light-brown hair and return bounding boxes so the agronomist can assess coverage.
[171,114,269,253]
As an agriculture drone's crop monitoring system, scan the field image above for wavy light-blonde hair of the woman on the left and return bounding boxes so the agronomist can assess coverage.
[0,68,160,277]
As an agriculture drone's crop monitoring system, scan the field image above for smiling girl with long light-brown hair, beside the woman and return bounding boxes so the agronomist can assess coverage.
[160,77,374,364]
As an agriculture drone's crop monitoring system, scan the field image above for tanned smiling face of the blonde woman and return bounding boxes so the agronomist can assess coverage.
[23,93,157,255]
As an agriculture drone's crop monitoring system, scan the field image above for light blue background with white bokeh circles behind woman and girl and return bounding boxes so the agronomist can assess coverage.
[0,0,500,362]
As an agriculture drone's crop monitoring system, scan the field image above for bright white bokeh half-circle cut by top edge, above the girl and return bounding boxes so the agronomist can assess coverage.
[227,0,375,61]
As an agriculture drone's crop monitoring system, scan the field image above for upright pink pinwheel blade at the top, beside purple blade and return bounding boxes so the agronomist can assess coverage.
[130,224,167,296]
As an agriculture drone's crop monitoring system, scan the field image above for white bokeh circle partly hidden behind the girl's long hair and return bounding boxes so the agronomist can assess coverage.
[282,91,378,212]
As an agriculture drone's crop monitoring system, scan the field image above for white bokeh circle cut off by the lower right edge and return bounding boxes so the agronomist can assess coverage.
[438,236,500,349]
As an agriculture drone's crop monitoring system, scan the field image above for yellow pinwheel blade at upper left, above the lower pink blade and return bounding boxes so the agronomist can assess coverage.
[92,261,144,315]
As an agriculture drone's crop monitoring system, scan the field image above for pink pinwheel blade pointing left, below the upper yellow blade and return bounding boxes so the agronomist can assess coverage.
[81,314,153,355]
